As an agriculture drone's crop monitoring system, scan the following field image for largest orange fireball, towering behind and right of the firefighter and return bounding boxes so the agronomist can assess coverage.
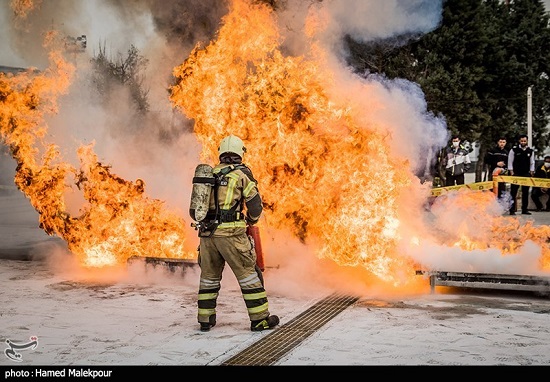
[171,1,416,280]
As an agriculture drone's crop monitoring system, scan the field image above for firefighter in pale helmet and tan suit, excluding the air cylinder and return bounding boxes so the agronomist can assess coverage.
[198,135,279,332]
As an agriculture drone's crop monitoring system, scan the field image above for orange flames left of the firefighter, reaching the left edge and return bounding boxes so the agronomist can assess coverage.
[0,33,196,267]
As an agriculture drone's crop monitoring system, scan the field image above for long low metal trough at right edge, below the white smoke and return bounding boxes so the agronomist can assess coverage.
[416,270,550,294]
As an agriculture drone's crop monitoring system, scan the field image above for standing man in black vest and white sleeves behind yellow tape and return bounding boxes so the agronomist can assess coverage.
[508,134,535,215]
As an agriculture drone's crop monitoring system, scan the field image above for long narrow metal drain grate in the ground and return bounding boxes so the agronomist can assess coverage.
[221,294,359,366]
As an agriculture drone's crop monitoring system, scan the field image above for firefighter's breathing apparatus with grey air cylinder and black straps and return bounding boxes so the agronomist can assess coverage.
[189,163,246,237]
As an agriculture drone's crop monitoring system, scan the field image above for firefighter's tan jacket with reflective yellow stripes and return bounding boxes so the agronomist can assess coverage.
[207,163,263,236]
